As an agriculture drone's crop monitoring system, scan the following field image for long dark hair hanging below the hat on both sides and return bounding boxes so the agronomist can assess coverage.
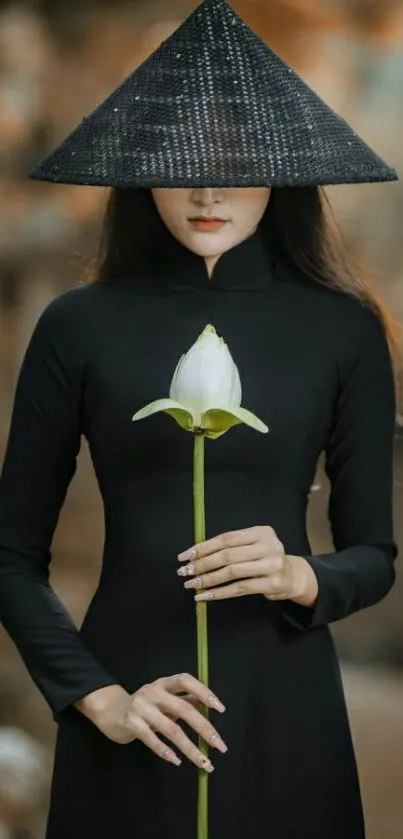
[85,187,401,398]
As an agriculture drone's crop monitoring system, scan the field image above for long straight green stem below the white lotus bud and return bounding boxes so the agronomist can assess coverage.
[193,434,208,839]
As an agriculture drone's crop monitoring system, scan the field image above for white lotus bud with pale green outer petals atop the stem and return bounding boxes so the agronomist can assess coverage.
[133,325,268,438]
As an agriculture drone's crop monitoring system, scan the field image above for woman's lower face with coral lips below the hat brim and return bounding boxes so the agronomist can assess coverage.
[151,187,270,260]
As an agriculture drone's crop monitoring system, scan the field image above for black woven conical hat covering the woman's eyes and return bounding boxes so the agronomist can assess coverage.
[31,0,397,188]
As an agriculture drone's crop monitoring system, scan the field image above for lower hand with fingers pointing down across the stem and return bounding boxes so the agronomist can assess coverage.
[76,673,227,772]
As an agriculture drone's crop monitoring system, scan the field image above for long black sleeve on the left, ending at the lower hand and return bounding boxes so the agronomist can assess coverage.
[0,291,116,718]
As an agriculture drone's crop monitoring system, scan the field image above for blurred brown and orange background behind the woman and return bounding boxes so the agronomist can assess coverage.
[0,0,403,839]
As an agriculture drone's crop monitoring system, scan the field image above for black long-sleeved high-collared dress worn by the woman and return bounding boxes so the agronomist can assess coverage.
[0,234,397,839]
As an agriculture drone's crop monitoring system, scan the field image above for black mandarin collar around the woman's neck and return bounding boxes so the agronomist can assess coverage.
[152,230,274,293]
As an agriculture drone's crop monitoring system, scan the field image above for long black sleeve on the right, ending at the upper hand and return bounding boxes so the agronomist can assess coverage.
[283,311,398,629]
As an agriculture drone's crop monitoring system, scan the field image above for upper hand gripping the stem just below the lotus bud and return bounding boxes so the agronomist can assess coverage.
[178,526,318,606]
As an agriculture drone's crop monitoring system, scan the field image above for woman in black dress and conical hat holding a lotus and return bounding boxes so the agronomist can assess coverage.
[0,0,397,839]
